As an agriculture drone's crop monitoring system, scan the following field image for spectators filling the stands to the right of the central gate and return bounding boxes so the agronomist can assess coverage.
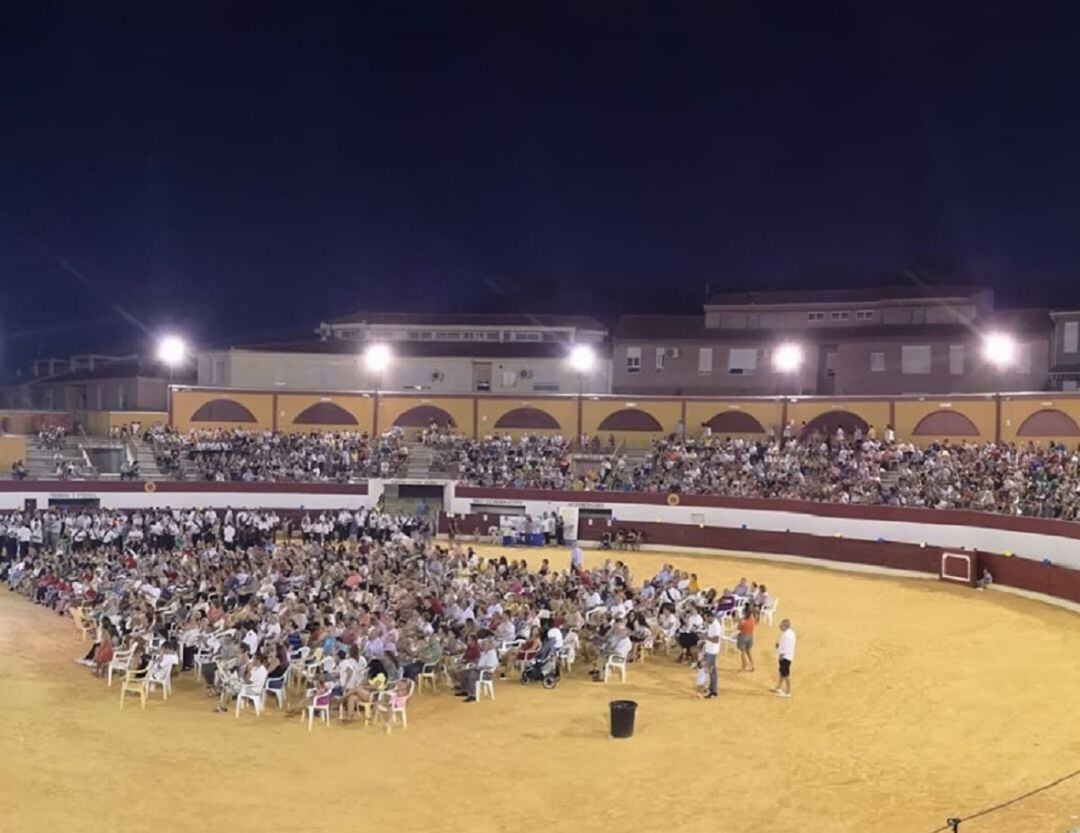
[428,426,1080,520]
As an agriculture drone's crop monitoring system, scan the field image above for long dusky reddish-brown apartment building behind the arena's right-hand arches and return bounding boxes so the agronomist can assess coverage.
[611,286,1049,395]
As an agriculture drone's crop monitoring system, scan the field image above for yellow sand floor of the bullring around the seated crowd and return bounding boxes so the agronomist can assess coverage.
[0,551,1080,833]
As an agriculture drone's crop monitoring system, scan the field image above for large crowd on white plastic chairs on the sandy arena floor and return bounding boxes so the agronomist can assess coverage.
[0,510,768,716]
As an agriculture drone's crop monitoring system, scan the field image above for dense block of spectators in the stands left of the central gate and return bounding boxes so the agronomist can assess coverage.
[144,425,408,482]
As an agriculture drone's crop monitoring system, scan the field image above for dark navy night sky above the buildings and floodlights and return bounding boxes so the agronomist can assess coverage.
[0,2,1080,372]
